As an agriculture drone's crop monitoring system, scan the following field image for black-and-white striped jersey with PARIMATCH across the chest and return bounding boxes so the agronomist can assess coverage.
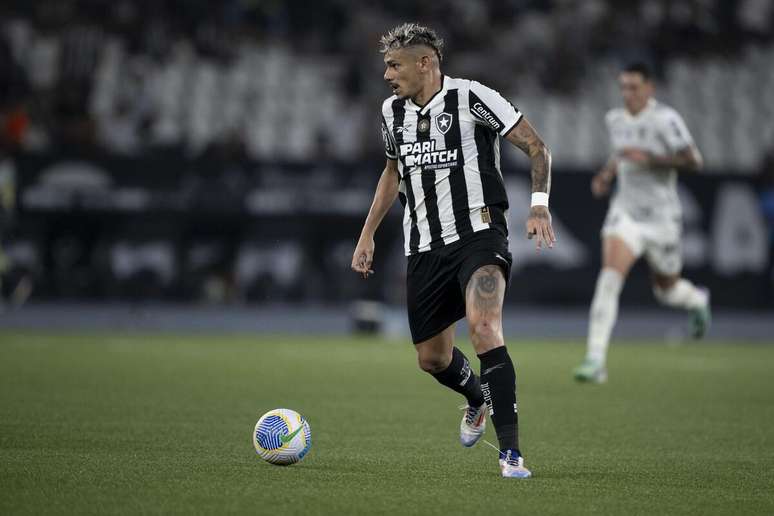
[382,77,522,256]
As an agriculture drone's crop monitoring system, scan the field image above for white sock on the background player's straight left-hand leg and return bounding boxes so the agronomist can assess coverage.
[586,268,623,364]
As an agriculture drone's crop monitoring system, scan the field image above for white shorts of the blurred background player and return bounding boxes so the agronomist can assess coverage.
[602,205,683,275]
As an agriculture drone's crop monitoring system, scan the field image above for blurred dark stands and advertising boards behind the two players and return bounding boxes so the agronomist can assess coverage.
[0,0,774,309]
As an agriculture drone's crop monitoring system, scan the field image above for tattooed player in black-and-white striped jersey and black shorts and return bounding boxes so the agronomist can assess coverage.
[352,23,555,478]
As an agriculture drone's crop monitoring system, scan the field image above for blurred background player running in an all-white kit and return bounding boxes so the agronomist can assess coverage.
[574,64,710,383]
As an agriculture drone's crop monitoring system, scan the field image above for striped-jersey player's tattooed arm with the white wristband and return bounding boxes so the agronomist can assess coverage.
[506,116,556,249]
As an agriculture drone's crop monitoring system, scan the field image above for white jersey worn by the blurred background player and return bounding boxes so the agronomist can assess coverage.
[605,99,693,221]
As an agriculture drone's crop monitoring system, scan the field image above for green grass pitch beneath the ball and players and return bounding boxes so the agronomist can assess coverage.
[0,332,774,515]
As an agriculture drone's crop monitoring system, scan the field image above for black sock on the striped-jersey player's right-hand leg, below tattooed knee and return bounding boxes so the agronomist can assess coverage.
[478,346,521,453]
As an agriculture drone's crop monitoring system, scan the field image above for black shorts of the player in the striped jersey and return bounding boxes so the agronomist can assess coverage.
[406,229,513,344]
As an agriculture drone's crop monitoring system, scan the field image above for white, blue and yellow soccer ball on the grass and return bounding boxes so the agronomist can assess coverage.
[253,409,312,466]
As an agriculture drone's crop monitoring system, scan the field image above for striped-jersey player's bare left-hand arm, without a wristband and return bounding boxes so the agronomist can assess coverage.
[352,159,400,278]
